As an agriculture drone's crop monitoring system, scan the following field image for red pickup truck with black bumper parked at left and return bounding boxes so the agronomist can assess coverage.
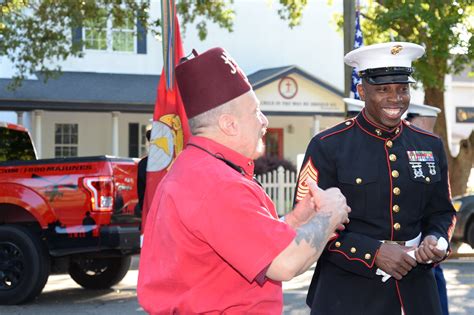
[0,122,141,304]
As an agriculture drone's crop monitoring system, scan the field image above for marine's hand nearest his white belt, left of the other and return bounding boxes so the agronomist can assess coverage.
[375,243,416,280]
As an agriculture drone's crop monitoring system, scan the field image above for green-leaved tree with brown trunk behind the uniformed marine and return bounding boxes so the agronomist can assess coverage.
[336,0,474,195]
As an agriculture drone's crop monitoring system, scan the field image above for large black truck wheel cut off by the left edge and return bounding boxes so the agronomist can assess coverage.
[0,225,50,305]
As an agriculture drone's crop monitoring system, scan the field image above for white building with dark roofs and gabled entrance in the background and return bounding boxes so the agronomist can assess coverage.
[0,0,474,173]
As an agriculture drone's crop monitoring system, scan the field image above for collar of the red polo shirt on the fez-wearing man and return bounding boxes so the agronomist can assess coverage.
[189,136,255,179]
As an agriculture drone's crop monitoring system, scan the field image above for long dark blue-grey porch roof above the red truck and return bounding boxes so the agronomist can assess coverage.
[0,72,160,112]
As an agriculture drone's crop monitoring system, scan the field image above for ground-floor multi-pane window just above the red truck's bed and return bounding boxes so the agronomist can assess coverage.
[54,124,79,157]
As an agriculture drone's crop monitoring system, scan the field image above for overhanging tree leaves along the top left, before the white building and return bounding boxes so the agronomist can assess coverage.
[0,0,307,88]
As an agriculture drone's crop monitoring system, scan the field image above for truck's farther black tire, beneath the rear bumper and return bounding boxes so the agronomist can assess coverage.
[69,256,132,289]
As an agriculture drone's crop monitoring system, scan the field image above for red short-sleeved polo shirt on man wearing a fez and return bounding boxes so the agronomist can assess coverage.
[138,137,295,314]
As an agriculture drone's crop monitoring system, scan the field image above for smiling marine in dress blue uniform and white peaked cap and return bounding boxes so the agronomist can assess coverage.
[295,43,455,315]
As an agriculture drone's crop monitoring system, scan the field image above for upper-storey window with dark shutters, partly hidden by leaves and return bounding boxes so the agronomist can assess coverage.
[83,12,136,52]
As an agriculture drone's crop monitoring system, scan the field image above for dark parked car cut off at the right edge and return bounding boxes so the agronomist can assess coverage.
[451,194,474,250]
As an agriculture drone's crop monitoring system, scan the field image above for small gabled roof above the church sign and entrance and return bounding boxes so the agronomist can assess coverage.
[248,65,344,97]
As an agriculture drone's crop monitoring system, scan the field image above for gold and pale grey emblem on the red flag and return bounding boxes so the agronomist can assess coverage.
[147,114,184,172]
